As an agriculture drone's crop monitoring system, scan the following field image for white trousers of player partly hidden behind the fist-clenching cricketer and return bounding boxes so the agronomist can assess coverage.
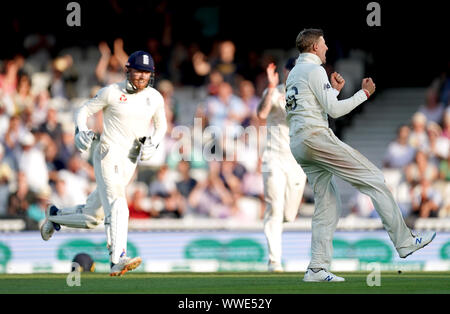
[262,152,306,265]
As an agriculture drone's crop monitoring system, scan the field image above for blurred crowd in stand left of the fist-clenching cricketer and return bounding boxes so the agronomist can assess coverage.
[0,35,286,229]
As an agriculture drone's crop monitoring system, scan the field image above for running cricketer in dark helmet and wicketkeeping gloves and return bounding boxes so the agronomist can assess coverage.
[41,51,167,276]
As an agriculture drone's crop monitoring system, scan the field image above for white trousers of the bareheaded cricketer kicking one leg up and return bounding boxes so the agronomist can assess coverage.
[290,128,412,270]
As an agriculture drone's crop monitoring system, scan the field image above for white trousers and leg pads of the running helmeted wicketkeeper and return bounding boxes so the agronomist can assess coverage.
[49,143,136,263]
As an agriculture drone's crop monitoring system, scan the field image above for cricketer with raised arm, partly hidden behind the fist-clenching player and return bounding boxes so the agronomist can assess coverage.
[257,58,306,272]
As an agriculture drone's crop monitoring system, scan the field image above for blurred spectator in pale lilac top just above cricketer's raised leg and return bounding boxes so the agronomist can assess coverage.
[383,125,416,169]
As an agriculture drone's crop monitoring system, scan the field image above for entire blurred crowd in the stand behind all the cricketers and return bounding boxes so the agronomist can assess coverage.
[0,34,450,229]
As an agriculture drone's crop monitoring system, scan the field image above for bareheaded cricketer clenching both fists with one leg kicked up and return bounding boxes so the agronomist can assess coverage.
[286,29,436,281]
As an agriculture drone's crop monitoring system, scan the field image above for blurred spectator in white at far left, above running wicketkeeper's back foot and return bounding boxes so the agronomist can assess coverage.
[17,132,49,193]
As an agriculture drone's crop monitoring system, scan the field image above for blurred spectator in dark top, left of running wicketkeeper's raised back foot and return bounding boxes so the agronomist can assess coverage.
[8,171,35,218]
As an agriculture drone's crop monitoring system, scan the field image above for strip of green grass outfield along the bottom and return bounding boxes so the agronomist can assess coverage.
[0,272,450,294]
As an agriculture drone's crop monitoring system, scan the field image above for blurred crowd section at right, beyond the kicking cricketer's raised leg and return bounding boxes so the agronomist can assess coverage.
[350,78,450,221]
